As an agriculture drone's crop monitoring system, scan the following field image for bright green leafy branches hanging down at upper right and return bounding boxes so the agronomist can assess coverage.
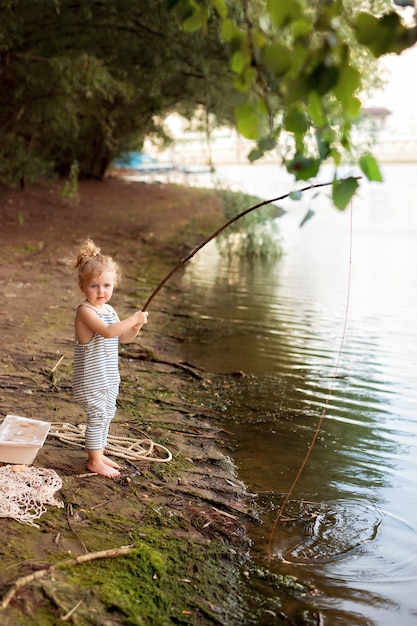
[172,0,417,209]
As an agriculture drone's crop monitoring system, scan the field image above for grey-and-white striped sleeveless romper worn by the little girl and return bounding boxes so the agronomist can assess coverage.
[73,303,120,450]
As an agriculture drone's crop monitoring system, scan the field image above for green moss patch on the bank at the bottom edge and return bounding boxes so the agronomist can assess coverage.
[64,526,242,626]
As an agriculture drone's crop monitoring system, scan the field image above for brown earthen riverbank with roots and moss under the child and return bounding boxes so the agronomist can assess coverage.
[0,179,251,626]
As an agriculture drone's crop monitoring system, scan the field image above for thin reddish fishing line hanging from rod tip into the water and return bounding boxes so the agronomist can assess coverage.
[267,201,353,559]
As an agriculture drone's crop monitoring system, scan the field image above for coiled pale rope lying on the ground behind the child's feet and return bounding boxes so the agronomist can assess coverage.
[48,422,172,463]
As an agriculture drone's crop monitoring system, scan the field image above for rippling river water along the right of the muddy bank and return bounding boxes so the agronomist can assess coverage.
[177,164,417,626]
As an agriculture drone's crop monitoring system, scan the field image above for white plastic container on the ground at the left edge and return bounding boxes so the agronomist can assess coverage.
[0,415,51,465]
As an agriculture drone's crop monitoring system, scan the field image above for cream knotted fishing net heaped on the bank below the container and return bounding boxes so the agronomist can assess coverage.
[0,465,64,528]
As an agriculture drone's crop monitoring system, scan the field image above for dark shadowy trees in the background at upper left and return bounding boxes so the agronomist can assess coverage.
[0,0,234,185]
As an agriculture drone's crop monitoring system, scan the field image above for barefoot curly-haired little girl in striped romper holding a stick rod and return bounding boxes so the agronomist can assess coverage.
[73,239,148,478]
